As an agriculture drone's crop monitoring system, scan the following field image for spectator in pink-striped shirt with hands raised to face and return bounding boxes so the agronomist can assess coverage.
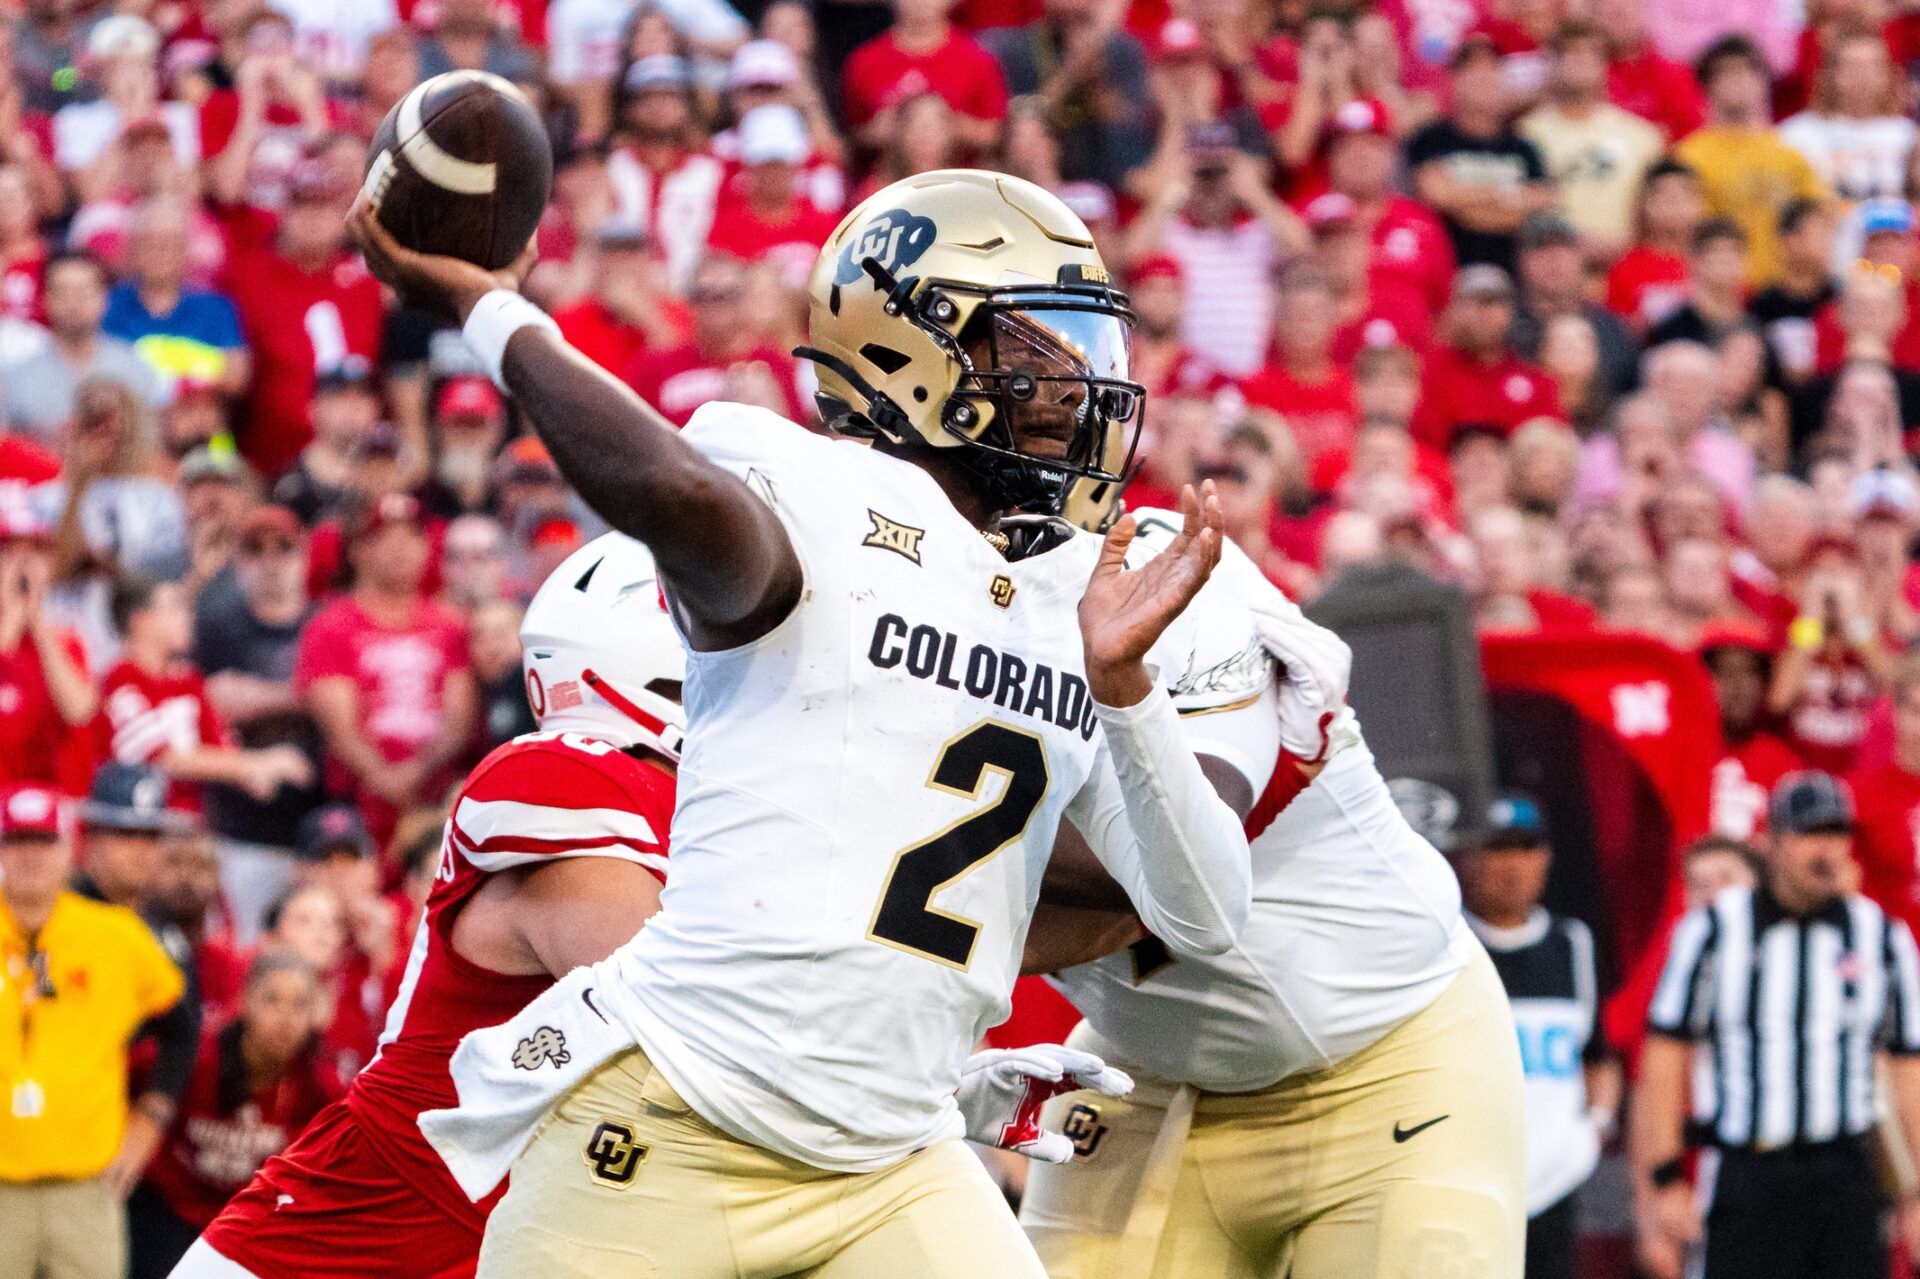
[1125,121,1306,376]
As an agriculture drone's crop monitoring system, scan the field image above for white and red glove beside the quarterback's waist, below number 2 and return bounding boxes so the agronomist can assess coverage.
[954,1043,1133,1164]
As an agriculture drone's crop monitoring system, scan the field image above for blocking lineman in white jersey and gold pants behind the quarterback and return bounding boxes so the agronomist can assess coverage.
[1021,511,1526,1279]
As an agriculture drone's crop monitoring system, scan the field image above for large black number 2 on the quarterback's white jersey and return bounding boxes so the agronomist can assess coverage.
[866,720,1050,970]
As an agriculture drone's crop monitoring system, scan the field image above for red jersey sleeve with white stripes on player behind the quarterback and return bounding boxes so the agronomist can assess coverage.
[447,737,672,881]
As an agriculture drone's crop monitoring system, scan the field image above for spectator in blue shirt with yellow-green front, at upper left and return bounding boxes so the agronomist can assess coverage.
[100,198,248,396]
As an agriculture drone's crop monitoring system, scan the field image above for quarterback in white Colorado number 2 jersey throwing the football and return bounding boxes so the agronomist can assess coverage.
[351,171,1250,1279]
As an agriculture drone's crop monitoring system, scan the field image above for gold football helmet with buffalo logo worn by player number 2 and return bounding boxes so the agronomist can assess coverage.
[795,169,1144,515]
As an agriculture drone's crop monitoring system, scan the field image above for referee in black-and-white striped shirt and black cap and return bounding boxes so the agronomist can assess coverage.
[1634,772,1920,1279]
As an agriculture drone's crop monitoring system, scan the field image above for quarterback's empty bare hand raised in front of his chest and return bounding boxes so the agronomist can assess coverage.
[1079,480,1225,707]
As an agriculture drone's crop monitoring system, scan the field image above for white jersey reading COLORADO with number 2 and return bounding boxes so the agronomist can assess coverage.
[583,403,1228,1171]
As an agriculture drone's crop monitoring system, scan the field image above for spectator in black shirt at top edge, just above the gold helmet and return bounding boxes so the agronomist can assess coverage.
[981,0,1152,188]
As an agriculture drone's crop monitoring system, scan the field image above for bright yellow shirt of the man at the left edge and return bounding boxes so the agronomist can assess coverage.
[0,893,184,1181]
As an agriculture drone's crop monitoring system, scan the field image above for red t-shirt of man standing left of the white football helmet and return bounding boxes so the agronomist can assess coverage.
[294,595,467,795]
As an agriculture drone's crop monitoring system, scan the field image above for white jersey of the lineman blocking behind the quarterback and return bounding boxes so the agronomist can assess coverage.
[1050,511,1478,1093]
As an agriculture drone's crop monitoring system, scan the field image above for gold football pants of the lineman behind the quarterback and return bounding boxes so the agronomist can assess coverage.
[1020,947,1526,1279]
